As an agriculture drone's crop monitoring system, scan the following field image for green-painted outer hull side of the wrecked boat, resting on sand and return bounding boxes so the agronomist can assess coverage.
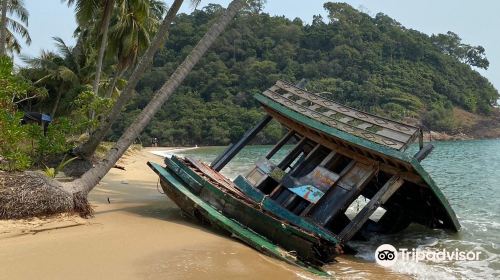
[148,162,329,276]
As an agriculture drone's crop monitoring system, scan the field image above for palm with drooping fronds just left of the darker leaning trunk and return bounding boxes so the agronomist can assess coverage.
[105,0,165,98]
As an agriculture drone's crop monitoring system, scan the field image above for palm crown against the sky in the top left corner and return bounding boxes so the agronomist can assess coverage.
[0,0,31,55]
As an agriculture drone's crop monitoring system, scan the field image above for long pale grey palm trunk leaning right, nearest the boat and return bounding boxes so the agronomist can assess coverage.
[65,0,247,194]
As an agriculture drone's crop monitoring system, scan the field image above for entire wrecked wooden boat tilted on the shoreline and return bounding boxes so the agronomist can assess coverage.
[148,81,460,273]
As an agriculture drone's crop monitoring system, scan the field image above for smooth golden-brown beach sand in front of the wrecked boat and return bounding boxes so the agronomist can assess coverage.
[0,148,402,279]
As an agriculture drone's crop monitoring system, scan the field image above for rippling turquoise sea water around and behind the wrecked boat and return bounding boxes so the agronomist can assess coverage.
[173,140,500,279]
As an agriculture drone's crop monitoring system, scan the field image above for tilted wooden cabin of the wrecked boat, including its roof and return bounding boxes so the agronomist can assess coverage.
[211,81,459,242]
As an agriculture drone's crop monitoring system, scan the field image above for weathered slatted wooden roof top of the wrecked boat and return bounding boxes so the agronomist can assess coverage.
[257,80,421,150]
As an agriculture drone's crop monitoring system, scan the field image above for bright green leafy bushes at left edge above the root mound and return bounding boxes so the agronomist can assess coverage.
[0,57,74,171]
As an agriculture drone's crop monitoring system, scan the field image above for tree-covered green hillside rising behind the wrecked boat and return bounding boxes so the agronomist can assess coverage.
[111,3,499,145]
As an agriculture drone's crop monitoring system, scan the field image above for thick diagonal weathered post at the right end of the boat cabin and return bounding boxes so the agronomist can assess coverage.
[339,176,405,242]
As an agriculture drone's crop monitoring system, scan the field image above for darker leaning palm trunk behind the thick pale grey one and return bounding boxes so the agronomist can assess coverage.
[74,0,184,159]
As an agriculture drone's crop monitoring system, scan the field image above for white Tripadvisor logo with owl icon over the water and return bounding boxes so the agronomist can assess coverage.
[375,244,481,267]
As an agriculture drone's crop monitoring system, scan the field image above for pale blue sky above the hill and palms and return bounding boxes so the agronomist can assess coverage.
[16,0,500,89]
